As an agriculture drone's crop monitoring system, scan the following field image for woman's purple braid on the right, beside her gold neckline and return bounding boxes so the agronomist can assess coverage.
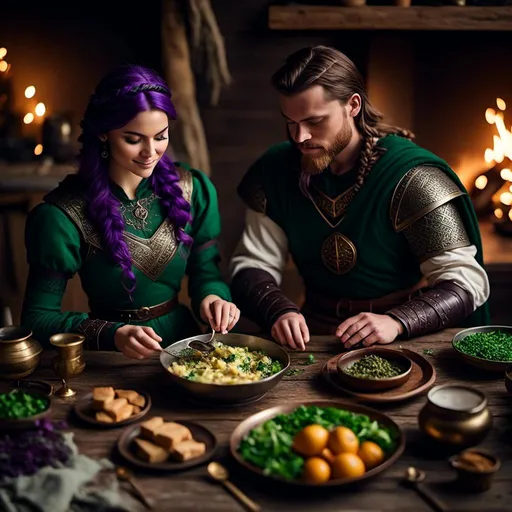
[152,157,193,245]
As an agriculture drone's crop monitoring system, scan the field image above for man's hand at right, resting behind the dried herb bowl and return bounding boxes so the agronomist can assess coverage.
[336,313,404,349]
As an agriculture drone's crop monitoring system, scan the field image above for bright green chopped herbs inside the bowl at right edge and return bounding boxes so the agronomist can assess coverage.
[455,331,512,361]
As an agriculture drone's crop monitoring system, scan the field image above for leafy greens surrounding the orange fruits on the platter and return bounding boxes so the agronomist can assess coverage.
[238,405,398,480]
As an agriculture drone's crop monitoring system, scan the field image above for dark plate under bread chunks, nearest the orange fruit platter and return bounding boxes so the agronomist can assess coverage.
[117,418,217,471]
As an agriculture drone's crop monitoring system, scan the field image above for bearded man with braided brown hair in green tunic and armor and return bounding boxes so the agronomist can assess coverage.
[231,46,489,350]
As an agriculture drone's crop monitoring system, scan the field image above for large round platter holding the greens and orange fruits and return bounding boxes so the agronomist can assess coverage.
[229,400,405,488]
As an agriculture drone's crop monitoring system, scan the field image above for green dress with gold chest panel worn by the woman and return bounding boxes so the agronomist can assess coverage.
[22,164,231,350]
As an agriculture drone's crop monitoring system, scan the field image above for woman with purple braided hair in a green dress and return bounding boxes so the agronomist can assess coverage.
[22,65,240,359]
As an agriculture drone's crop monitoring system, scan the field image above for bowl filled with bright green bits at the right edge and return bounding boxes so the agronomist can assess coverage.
[452,325,512,372]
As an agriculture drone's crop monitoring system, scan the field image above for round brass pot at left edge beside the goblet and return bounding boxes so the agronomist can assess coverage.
[0,325,43,379]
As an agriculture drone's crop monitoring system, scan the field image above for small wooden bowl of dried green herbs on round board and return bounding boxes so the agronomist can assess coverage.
[337,347,412,392]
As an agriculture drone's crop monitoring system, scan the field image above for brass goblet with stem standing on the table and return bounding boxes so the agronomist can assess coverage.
[50,333,85,398]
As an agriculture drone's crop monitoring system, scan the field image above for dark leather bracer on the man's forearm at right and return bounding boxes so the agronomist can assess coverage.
[386,281,473,338]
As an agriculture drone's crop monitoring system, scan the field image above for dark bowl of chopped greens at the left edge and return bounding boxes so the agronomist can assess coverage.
[0,389,51,432]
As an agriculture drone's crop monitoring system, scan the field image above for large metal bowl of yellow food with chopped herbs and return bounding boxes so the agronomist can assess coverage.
[160,333,290,405]
